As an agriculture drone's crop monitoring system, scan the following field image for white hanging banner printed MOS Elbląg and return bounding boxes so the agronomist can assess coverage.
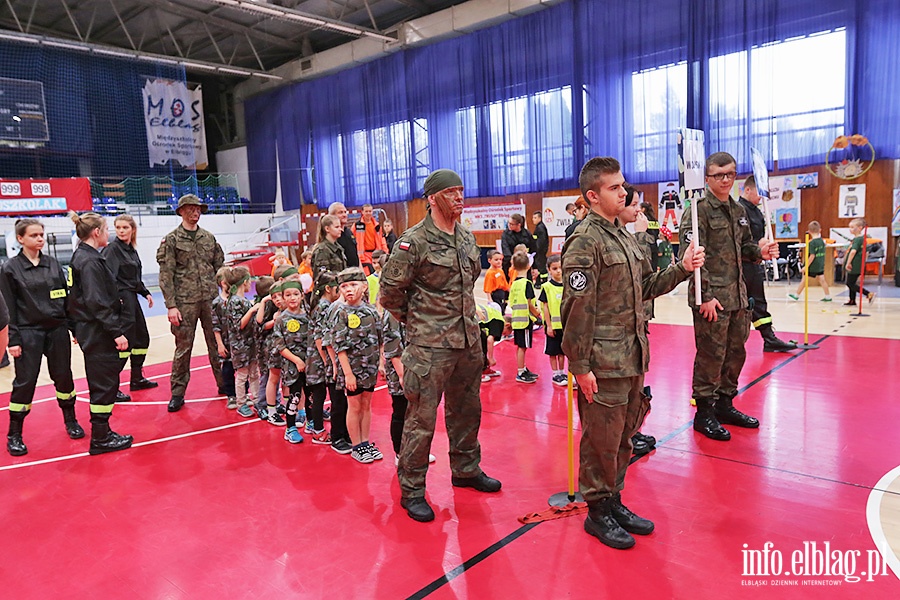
[143,79,209,169]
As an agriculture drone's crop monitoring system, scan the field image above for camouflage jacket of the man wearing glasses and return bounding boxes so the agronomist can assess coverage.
[678,192,762,311]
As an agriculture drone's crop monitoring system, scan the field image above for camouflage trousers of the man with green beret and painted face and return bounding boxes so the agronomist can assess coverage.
[397,343,484,498]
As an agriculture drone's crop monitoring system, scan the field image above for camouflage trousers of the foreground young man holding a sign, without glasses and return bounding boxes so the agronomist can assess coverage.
[578,375,650,502]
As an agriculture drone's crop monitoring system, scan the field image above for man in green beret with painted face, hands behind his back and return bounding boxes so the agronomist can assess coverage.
[381,169,500,522]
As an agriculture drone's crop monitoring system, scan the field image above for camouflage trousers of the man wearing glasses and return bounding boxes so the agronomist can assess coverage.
[693,309,750,400]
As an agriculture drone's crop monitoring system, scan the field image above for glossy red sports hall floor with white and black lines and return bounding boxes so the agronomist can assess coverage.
[0,324,900,599]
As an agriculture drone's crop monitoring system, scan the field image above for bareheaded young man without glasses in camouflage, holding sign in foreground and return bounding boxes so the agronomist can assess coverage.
[561,157,703,548]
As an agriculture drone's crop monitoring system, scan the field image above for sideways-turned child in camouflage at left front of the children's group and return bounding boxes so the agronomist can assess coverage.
[225,267,259,418]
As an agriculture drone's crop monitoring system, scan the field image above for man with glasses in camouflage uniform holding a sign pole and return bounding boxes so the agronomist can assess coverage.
[681,152,778,441]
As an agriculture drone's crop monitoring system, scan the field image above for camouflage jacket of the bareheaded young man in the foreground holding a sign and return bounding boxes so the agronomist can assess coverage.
[560,211,688,378]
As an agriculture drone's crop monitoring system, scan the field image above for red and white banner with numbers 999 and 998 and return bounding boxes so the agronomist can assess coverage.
[0,177,92,215]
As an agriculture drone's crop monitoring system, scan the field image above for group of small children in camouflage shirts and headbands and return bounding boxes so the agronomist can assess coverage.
[213,253,406,464]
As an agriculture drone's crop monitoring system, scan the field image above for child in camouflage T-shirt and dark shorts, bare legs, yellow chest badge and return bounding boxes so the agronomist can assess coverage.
[332,267,384,463]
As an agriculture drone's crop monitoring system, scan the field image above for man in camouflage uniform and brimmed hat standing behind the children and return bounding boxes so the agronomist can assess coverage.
[156,194,225,412]
